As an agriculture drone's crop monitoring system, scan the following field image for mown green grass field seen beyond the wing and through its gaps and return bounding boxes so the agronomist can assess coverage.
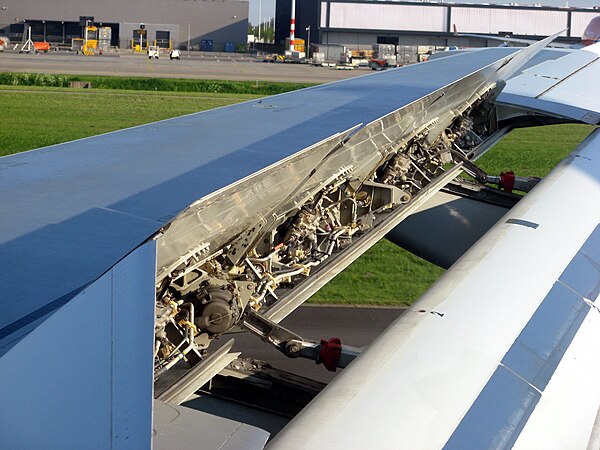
[0,86,593,305]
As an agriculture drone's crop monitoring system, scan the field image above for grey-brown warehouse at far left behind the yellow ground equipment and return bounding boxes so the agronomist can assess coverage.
[0,0,248,51]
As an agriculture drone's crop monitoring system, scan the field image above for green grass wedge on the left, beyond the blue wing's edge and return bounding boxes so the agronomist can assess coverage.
[0,88,260,156]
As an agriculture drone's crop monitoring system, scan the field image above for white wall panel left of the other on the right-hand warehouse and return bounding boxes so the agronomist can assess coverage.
[329,2,447,32]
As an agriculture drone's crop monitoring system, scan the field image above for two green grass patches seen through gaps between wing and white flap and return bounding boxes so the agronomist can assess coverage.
[310,124,595,305]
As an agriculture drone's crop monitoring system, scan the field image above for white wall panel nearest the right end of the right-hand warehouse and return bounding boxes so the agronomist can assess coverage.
[450,7,567,36]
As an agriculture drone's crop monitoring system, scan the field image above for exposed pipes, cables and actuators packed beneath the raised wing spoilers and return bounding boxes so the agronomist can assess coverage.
[154,89,496,376]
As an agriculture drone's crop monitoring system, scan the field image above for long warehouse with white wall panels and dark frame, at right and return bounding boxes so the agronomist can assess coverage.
[275,0,600,49]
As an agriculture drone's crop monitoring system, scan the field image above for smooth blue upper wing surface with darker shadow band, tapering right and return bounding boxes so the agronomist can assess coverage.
[0,49,524,354]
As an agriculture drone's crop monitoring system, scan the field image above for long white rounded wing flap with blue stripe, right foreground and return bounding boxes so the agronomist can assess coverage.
[269,131,600,449]
